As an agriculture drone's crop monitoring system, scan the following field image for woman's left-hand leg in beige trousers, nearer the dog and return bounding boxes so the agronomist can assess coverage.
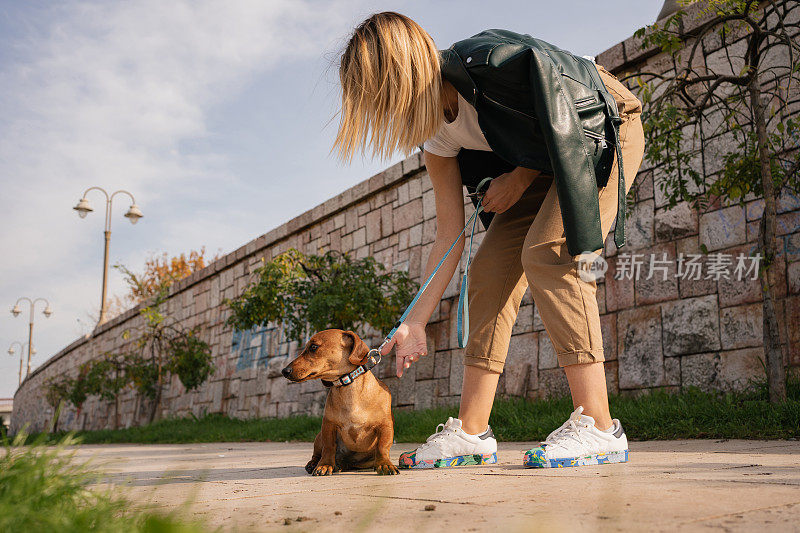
[458,176,552,435]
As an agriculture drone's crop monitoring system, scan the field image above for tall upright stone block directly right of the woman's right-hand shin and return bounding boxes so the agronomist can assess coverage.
[616,306,666,389]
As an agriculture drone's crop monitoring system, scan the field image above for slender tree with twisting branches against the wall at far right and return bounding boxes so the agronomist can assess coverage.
[636,0,800,402]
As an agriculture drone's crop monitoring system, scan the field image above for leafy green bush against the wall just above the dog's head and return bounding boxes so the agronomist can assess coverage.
[225,249,417,341]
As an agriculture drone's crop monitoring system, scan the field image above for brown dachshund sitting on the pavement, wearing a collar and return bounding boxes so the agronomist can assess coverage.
[282,329,399,476]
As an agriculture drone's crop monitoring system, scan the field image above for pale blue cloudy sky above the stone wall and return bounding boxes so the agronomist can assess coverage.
[0,0,661,398]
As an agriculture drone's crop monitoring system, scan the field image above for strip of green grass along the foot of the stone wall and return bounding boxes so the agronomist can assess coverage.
[32,380,800,444]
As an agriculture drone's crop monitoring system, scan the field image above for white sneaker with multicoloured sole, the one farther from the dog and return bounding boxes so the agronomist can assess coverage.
[522,407,628,468]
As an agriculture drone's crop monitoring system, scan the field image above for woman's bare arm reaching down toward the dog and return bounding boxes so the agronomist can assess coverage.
[382,152,464,376]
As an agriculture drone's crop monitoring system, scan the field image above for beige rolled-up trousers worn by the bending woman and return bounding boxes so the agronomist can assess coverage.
[464,66,644,373]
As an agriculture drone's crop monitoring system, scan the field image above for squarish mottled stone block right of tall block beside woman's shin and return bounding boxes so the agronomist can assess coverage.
[661,295,720,356]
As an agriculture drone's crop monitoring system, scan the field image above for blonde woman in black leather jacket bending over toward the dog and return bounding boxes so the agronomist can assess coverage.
[334,12,644,468]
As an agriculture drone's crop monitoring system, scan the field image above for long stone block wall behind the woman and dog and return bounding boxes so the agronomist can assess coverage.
[12,3,800,430]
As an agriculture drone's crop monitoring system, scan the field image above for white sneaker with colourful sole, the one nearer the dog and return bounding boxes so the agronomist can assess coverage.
[400,417,497,468]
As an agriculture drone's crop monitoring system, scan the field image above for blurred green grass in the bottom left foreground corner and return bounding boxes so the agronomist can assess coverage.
[0,435,211,533]
